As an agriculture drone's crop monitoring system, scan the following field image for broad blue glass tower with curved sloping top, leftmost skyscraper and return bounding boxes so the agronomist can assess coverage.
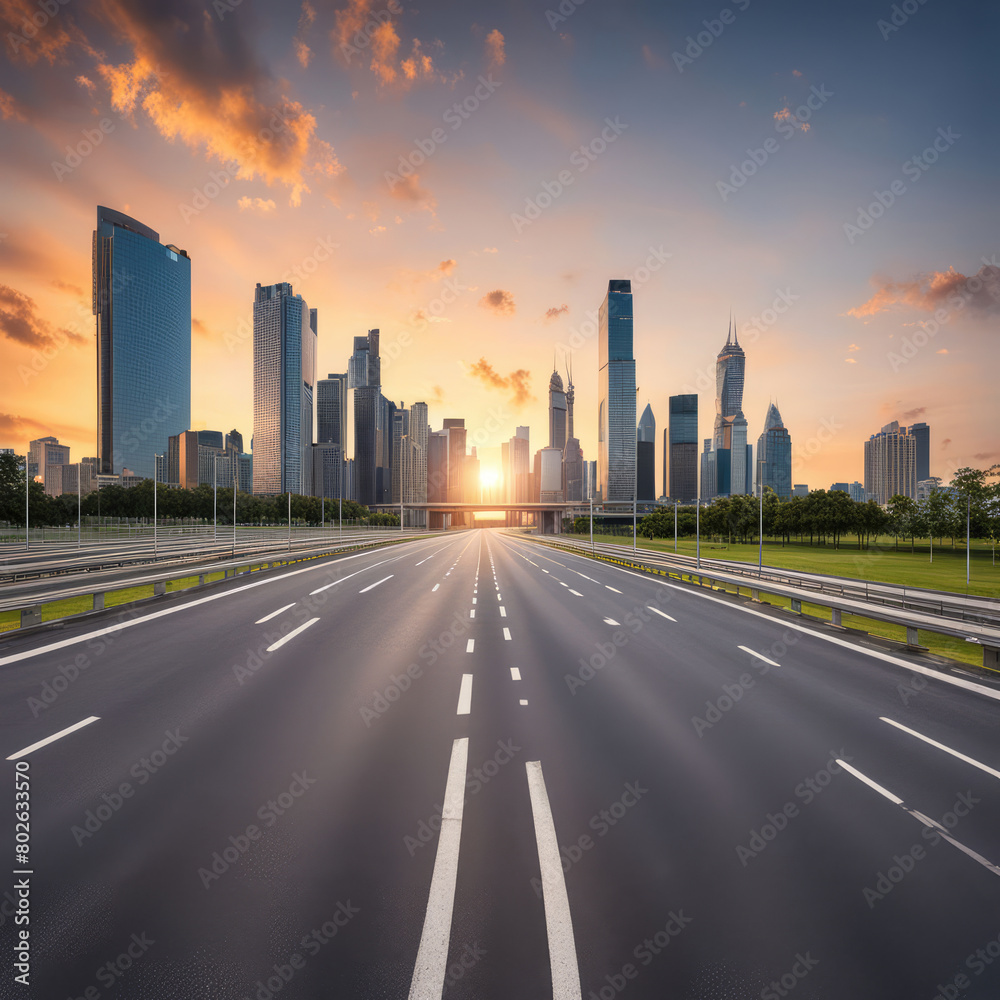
[92,205,191,479]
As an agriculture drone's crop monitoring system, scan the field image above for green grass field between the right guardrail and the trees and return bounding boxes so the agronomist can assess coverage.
[573,534,1000,597]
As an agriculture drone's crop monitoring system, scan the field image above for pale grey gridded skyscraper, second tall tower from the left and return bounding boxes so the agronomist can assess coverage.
[253,281,316,496]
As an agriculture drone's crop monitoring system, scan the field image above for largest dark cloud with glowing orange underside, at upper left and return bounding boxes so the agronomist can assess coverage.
[86,0,338,205]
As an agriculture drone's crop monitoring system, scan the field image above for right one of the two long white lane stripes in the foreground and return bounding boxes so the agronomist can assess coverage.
[521,760,583,1000]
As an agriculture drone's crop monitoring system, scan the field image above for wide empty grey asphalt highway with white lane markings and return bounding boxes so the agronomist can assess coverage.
[0,531,1000,1000]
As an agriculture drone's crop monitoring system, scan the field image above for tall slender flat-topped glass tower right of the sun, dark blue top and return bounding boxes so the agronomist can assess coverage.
[597,279,635,503]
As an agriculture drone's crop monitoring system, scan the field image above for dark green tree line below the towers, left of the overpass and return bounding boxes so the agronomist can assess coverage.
[0,455,399,527]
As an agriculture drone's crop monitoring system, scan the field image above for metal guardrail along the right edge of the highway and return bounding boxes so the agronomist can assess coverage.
[527,536,1000,670]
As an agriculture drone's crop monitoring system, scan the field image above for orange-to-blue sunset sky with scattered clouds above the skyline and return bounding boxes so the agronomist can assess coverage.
[0,0,1000,490]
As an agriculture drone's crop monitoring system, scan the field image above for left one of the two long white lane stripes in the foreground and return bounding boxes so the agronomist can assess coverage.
[409,736,468,1000]
